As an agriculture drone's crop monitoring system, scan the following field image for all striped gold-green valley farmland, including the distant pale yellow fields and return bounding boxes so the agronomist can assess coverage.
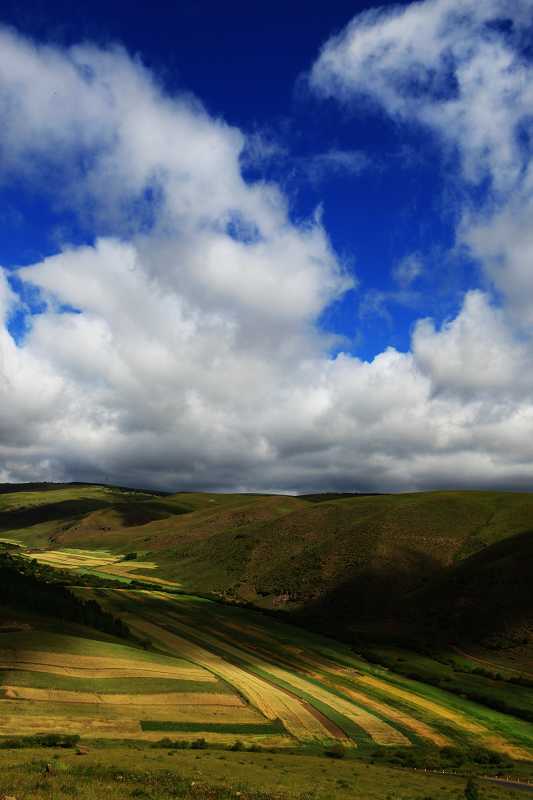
[0,490,533,796]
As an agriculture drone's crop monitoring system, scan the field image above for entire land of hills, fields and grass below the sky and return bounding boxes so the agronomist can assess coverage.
[0,484,533,800]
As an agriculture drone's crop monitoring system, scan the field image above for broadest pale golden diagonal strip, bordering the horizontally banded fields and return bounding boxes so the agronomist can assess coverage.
[112,592,347,742]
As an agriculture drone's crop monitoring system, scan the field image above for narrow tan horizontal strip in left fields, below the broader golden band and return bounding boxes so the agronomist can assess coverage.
[0,686,245,708]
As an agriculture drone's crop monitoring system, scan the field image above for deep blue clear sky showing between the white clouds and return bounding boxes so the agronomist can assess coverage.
[0,1,466,358]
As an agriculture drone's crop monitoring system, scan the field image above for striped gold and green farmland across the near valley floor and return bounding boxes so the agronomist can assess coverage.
[0,564,533,760]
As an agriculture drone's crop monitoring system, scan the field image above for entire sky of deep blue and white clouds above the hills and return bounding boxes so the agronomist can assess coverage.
[0,0,533,491]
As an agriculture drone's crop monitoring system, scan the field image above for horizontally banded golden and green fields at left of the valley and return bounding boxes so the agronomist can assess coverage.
[0,631,283,744]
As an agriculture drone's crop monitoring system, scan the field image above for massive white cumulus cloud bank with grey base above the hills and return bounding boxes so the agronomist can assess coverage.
[0,18,533,491]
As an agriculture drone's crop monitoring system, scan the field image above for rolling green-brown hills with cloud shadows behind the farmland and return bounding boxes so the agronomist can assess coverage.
[0,485,533,648]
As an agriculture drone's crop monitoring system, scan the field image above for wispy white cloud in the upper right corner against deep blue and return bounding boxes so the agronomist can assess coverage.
[310,0,533,325]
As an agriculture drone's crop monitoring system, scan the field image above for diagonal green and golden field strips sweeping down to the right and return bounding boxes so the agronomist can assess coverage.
[97,589,533,759]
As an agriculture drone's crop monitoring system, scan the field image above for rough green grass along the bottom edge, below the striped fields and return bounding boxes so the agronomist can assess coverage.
[0,747,516,800]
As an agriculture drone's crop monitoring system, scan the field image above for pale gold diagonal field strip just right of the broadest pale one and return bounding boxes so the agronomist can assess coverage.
[158,615,411,747]
